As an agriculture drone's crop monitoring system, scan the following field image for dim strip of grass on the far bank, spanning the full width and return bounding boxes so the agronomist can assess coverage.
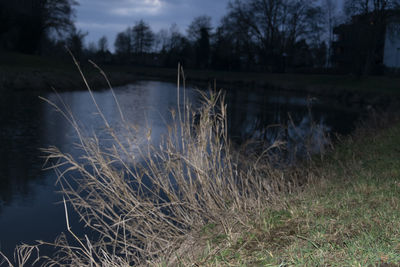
[0,53,400,96]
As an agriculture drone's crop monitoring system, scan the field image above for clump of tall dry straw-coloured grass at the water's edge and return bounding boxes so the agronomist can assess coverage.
[1,57,304,266]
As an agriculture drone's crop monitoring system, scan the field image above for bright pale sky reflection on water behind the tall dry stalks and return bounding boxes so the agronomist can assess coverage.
[44,82,197,159]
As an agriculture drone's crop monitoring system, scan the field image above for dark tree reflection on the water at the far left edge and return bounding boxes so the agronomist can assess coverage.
[0,93,42,210]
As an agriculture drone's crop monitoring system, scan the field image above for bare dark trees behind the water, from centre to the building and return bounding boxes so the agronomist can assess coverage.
[115,0,328,71]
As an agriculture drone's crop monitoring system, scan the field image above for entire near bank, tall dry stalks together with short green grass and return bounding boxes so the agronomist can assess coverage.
[0,60,400,266]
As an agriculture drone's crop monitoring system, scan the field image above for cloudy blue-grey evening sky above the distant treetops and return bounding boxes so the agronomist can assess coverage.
[76,0,229,50]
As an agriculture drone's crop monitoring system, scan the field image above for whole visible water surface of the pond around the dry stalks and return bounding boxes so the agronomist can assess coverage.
[0,81,359,262]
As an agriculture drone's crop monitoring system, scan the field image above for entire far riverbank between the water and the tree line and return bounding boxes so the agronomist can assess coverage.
[0,54,400,108]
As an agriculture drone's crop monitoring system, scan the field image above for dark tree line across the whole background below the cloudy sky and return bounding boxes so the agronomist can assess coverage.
[0,0,400,72]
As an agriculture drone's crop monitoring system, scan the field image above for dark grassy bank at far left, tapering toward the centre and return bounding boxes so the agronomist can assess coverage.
[0,53,172,91]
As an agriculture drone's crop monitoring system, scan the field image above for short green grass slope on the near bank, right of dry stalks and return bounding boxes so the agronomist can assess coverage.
[200,124,400,266]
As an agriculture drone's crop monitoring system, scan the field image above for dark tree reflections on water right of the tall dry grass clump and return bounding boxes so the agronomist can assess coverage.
[227,90,359,156]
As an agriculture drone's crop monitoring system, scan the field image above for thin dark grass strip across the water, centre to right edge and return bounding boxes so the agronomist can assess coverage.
[98,66,400,95]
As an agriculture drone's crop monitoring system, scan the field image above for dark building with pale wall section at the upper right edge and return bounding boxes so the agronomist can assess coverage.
[332,11,400,75]
